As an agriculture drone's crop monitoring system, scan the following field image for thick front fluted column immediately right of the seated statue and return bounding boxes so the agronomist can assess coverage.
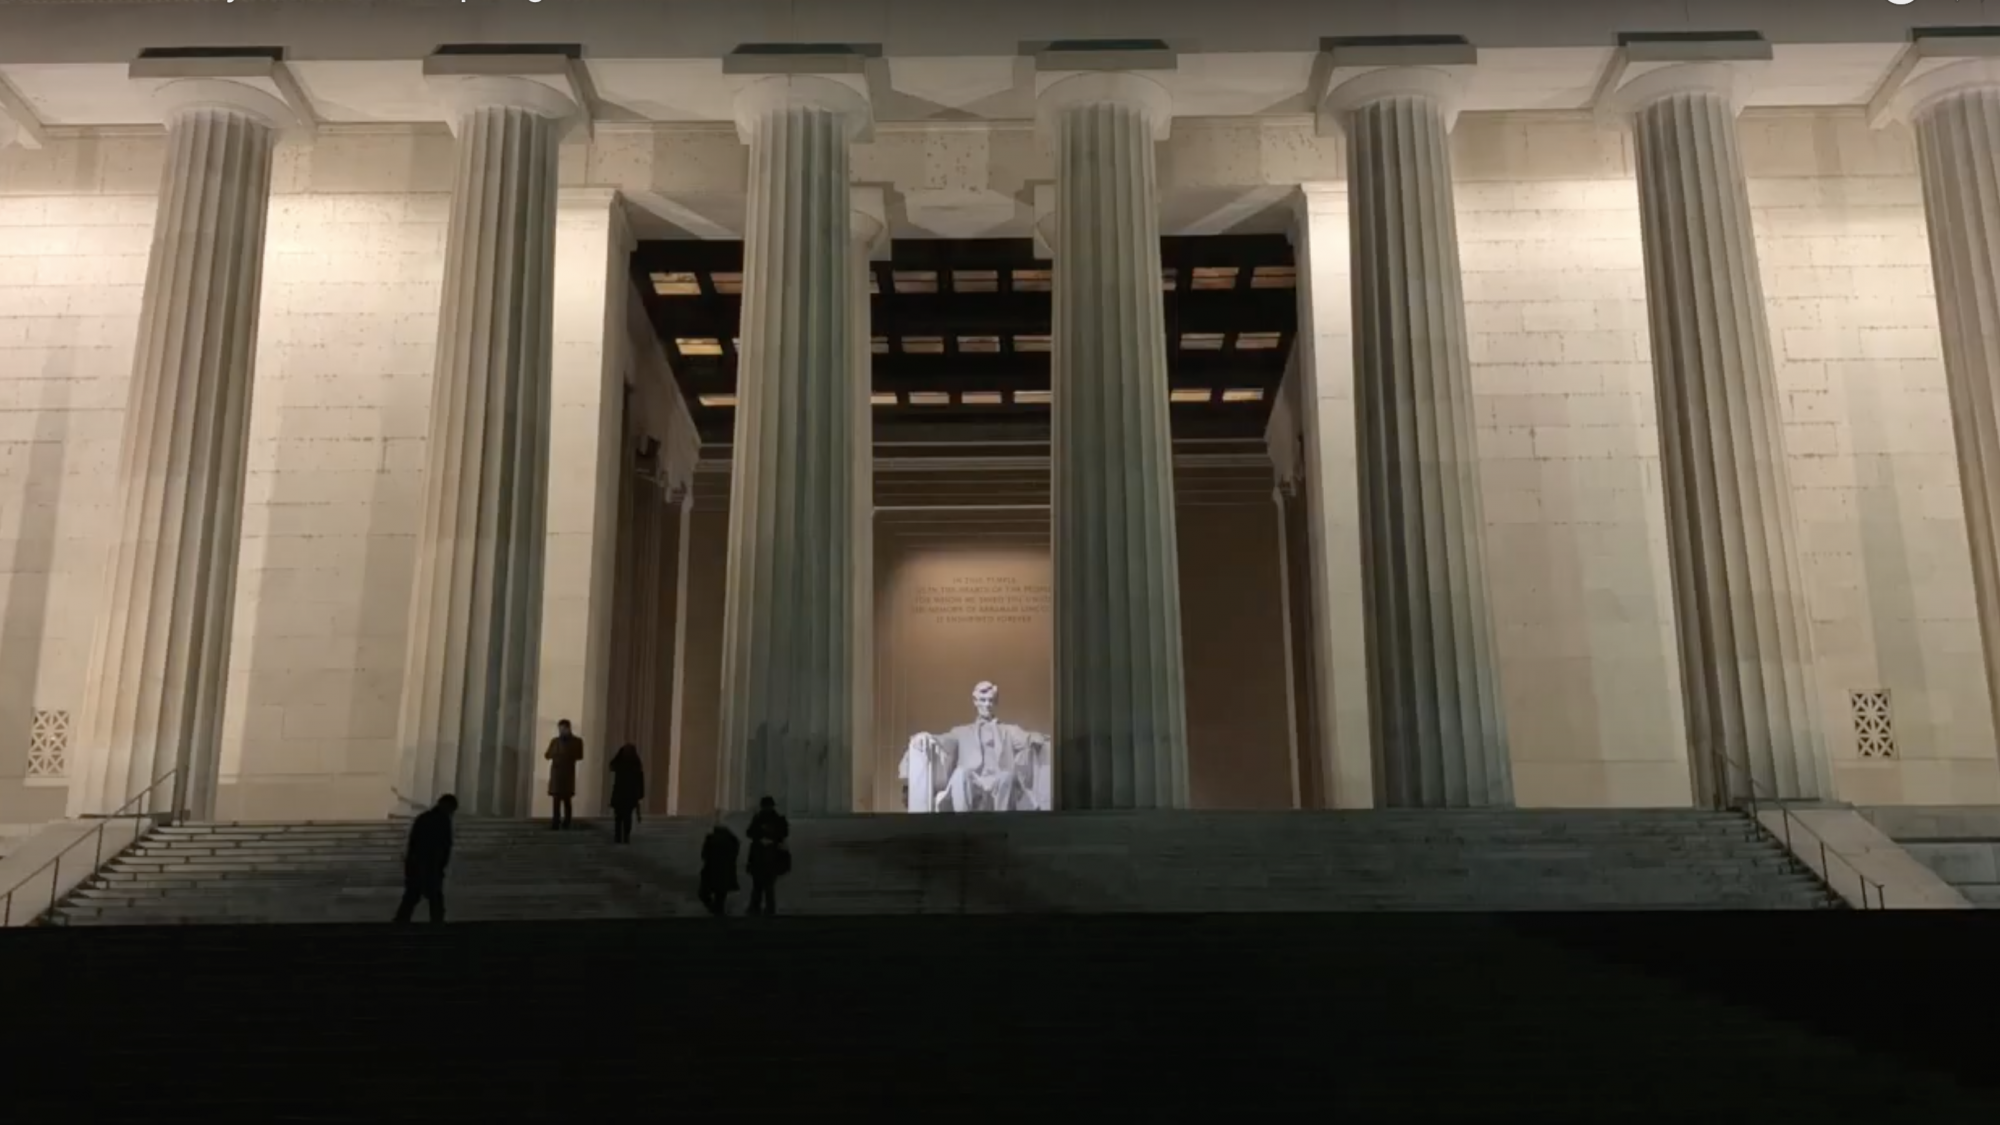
[1040,74,1188,809]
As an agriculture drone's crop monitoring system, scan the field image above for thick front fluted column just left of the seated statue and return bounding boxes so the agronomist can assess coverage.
[718,76,870,813]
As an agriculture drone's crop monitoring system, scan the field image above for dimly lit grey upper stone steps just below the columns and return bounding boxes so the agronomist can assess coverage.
[56,809,1830,925]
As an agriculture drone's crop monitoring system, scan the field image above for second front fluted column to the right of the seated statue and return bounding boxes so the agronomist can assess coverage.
[1328,68,1514,809]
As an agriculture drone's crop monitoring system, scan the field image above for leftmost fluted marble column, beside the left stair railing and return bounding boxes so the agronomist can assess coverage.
[70,78,292,819]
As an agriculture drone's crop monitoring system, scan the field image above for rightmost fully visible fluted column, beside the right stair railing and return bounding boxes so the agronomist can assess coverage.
[1616,64,1830,801]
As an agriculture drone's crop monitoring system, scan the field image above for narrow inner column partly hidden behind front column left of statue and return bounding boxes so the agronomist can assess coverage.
[848,190,886,807]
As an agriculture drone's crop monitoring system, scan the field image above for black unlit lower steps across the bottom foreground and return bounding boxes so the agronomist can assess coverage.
[0,911,2000,1121]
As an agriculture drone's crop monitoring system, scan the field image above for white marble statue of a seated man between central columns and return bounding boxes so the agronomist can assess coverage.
[896,683,1054,813]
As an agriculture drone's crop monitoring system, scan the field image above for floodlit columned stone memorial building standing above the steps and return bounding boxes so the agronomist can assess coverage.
[0,0,2000,825]
